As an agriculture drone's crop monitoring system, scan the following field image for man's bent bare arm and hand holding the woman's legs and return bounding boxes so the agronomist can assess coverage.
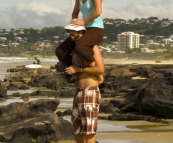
[65,45,104,75]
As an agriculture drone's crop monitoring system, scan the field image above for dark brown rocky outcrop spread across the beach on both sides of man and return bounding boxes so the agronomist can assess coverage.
[0,64,173,143]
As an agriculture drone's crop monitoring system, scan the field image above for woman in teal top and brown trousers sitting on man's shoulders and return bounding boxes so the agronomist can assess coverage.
[55,0,104,65]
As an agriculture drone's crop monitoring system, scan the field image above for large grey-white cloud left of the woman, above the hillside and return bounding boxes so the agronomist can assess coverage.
[0,2,71,29]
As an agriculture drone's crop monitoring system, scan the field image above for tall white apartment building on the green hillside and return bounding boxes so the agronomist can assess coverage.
[118,32,140,51]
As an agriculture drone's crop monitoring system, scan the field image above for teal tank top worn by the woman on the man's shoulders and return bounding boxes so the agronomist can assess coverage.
[79,0,104,28]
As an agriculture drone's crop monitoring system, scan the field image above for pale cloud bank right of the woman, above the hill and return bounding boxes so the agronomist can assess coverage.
[103,0,173,20]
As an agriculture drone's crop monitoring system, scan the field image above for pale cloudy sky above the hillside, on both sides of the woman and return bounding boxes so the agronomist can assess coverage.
[0,0,173,29]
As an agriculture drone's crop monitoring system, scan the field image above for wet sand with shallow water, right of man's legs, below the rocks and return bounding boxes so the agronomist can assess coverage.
[62,116,173,143]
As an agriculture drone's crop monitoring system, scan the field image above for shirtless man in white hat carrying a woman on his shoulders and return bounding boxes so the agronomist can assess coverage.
[65,26,104,143]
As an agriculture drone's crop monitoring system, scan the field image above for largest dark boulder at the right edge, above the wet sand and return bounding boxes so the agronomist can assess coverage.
[121,80,173,118]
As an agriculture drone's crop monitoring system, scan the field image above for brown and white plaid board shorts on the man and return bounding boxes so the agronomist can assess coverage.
[71,87,101,135]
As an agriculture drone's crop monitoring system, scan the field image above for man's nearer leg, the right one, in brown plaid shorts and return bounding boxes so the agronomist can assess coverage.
[77,87,100,143]
